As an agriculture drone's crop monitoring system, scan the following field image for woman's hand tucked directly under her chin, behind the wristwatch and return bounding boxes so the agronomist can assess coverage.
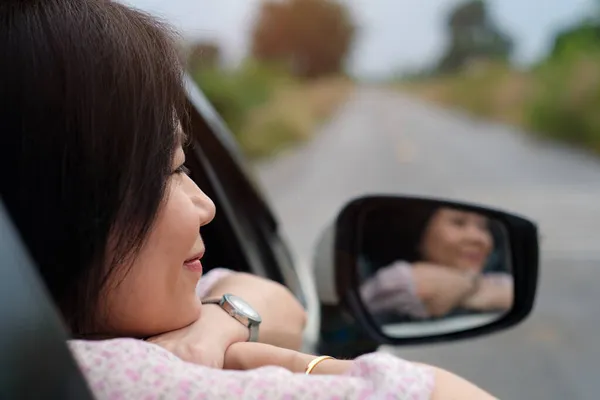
[148,305,249,369]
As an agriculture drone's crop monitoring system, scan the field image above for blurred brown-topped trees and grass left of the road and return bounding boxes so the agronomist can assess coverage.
[183,0,355,159]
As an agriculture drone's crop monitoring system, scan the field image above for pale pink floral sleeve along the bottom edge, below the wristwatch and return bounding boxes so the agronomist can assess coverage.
[69,339,434,400]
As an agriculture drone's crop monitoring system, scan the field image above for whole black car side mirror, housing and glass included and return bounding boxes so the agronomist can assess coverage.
[316,196,538,345]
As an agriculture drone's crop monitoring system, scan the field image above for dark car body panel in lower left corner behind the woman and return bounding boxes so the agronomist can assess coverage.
[0,201,93,400]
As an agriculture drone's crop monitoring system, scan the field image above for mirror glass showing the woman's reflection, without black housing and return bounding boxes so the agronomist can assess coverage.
[357,200,514,338]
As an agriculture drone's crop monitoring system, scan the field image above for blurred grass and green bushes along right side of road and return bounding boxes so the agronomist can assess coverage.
[399,57,600,154]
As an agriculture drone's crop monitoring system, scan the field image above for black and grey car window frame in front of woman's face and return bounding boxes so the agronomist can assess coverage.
[185,74,307,307]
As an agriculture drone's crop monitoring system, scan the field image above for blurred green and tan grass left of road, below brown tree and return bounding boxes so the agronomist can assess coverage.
[193,60,351,158]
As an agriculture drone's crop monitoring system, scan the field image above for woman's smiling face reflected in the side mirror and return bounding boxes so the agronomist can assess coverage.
[421,208,494,272]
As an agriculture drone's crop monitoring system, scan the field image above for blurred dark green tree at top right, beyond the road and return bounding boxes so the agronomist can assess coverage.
[437,0,513,73]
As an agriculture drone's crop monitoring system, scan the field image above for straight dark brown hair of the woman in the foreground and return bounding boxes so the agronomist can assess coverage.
[0,0,186,335]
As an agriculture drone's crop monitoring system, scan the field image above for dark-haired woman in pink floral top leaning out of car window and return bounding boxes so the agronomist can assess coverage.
[0,0,489,399]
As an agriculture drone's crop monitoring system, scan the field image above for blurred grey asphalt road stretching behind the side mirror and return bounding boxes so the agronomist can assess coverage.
[258,88,600,400]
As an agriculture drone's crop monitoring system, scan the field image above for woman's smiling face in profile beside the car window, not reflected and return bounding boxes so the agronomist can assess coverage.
[101,147,215,336]
